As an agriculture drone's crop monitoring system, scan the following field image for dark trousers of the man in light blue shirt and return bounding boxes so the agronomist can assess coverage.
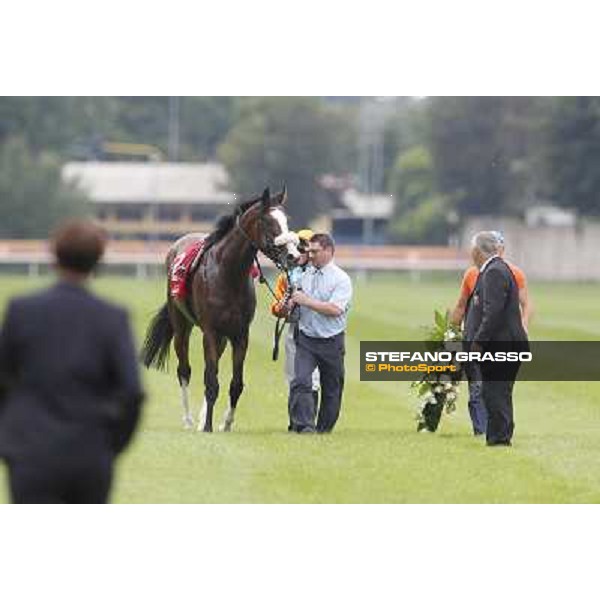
[289,331,345,433]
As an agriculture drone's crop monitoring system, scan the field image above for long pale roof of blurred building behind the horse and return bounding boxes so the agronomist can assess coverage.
[62,161,235,204]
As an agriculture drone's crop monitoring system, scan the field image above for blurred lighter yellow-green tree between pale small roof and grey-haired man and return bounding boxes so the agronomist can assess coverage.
[389,146,452,244]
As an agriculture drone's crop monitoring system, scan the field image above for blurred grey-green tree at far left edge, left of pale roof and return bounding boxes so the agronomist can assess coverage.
[0,137,87,238]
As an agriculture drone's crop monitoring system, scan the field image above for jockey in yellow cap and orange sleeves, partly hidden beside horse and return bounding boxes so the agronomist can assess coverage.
[271,229,320,431]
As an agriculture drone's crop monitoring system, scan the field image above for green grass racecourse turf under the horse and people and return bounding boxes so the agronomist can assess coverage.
[0,275,600,503]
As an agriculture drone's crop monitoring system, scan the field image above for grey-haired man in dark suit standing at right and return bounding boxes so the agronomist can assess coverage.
[465,231,529,446]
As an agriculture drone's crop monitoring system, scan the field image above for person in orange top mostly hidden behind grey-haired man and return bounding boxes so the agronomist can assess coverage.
[450,231,531,435]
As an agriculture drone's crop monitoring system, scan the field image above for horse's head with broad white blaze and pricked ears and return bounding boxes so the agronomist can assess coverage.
[240,187,300,268]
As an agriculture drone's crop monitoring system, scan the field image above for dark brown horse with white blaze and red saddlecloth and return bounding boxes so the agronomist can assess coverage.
[141,186,299,432]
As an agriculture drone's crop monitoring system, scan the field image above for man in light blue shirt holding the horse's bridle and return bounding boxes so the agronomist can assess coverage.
[289,233,352,433]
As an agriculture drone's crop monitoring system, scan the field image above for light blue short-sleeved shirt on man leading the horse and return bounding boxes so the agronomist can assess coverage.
[300,261,352,338]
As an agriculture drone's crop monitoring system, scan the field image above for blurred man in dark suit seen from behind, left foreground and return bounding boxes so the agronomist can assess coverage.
[0,221,143,503]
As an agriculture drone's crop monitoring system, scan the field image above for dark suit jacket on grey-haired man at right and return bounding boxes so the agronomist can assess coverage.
[465,257,527,350]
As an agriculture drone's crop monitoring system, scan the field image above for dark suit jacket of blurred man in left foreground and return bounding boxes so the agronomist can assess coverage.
[0,282,143,461]
